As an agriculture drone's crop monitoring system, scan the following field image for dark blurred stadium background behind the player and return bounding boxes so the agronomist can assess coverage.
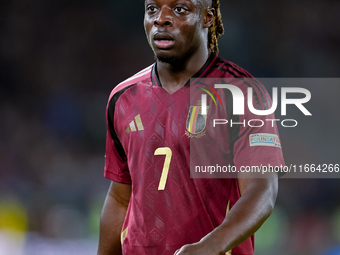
[0,0,340,255]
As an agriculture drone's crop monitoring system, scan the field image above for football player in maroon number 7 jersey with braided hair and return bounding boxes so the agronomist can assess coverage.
[98,0,284,255]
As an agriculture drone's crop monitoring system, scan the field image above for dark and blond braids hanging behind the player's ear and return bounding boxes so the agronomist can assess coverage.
[208,0,224,55]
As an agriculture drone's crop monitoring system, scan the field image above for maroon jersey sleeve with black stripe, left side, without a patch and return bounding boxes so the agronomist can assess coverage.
[104,93,131,184]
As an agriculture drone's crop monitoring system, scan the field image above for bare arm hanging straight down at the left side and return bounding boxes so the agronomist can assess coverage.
[97,182,131,255]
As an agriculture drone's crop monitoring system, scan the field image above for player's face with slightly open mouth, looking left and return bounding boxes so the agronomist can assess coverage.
[144,0,207,63]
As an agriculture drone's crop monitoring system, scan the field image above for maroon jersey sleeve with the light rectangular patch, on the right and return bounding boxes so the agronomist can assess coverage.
[228,78,284,175]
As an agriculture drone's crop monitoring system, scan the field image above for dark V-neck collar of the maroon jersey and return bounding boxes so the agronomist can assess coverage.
[151,52,218,87]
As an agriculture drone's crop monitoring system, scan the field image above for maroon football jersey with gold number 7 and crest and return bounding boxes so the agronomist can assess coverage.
[104,54,284,255]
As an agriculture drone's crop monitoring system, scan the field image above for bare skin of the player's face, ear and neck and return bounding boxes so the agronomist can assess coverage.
[144,0,214,93]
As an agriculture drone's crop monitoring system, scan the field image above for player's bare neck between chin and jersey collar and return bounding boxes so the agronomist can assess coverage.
[157,46,210,94]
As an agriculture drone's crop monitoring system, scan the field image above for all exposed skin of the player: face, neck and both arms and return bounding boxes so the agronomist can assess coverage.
[98,0,278,255]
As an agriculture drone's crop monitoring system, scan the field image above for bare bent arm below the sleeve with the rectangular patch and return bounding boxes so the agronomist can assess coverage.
[175,173,278,255]
